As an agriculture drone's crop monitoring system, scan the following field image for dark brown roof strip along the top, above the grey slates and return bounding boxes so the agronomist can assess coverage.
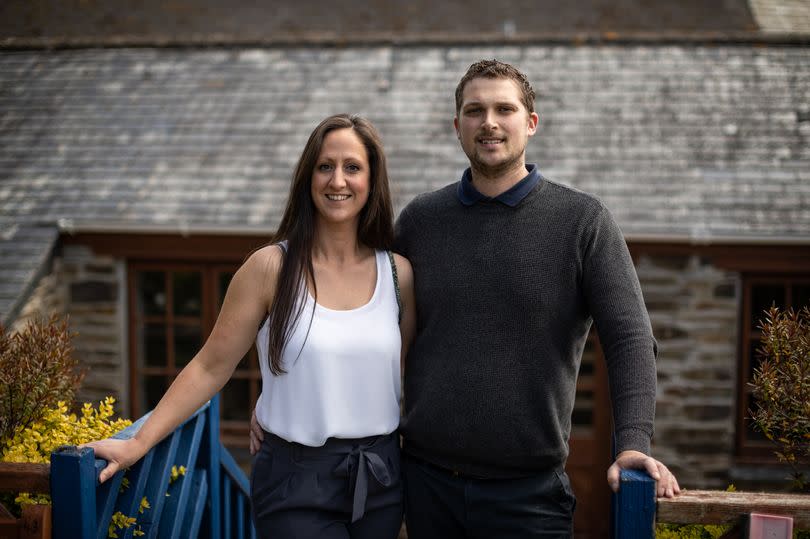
[0,0,756,45]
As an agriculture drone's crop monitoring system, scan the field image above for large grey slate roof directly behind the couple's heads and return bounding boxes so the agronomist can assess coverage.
[0,44,810,317]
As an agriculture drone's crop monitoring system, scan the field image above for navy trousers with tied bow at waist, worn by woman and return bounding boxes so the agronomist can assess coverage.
[250,432,403,539]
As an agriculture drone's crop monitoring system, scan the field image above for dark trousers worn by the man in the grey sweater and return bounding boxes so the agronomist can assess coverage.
[402,455,576,539]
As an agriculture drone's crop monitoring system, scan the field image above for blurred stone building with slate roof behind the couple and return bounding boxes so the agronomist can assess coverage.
[0,0,810,537]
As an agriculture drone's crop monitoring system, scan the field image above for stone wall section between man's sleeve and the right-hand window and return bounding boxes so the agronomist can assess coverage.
[637,255,740,489]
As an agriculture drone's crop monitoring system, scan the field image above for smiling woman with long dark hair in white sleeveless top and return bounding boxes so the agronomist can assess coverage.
[88,115,415,538]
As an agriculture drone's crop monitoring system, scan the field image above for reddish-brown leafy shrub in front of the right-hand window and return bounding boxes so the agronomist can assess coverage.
[749,307,810,492]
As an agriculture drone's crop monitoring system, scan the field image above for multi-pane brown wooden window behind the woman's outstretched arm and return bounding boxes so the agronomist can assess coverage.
[129,263,261,447]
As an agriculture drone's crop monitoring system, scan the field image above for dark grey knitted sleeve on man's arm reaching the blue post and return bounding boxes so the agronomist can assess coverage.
[583,206,658,455]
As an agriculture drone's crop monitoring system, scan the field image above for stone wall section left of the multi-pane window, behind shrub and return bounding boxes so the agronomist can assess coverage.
[12,245,128,416]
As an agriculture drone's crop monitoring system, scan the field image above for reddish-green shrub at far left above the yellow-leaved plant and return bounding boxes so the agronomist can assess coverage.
[0,316,83,442]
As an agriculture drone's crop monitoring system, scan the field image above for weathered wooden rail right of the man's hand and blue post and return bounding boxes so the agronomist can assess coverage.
[657,490,810,529]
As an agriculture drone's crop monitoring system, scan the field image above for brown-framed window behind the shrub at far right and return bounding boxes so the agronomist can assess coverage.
[737,275,810,460]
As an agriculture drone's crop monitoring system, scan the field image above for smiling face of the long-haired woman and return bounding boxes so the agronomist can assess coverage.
[311,127,371,230]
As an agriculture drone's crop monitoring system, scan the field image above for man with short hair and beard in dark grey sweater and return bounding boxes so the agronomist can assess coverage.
[252,60,679,539]
